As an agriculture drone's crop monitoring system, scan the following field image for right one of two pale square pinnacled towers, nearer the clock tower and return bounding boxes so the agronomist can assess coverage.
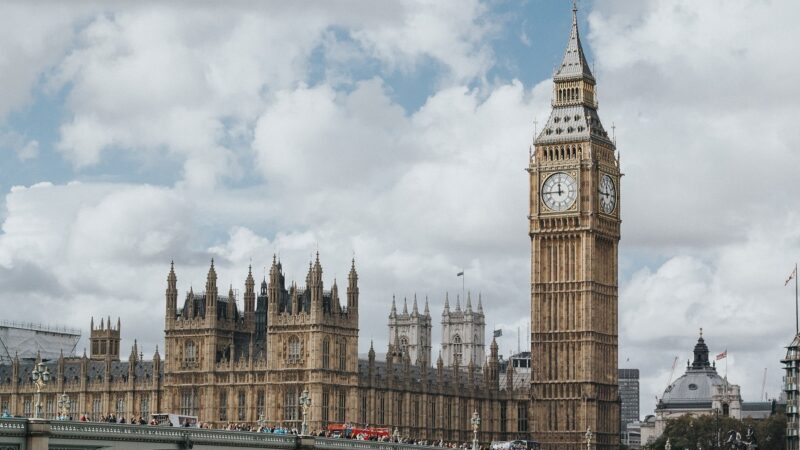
[442,293,486,367]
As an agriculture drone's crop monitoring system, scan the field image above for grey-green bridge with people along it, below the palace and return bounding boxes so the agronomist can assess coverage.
[0,419,432,450]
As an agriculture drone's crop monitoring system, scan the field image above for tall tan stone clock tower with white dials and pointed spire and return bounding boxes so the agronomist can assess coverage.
[529,3,620,450]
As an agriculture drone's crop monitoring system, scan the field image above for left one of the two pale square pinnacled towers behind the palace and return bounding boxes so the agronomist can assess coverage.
[389,295,432,366]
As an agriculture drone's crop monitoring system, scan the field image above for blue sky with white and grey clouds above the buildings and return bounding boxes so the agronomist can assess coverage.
[0,0,800,417]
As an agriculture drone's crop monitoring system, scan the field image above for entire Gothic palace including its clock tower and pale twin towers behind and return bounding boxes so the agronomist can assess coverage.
[0,8,620,450]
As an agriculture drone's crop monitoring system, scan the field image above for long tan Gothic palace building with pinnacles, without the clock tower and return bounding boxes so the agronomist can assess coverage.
[0,258,530,441]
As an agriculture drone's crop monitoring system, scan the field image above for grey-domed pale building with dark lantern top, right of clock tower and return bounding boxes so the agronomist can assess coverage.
[642,330,742,443]
